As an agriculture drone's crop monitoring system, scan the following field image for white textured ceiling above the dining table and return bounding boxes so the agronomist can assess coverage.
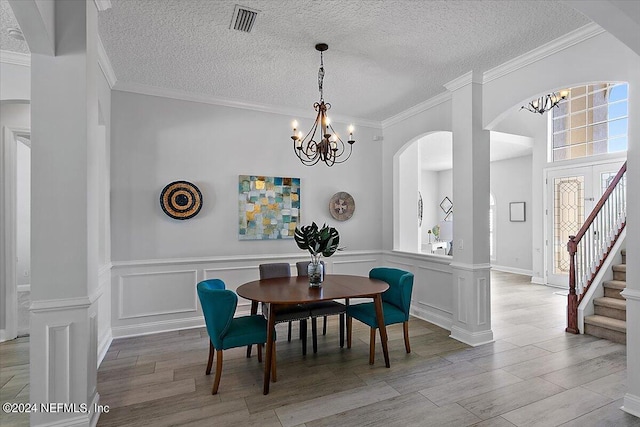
[99,0,590,121]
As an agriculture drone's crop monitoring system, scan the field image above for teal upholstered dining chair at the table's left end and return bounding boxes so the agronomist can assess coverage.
[197,279,267,394]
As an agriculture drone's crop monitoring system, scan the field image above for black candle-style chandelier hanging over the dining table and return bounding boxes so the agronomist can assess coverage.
[291,43,355,166]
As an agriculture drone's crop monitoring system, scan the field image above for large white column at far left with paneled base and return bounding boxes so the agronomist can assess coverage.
[30,0,99,426]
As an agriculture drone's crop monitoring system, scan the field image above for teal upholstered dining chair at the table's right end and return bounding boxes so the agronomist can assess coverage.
[347,267,413,365]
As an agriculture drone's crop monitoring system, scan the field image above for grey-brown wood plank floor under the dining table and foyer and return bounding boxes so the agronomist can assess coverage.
[0,273,640,427]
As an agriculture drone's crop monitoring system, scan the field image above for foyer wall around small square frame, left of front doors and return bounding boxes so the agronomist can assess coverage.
[491,156,541,275]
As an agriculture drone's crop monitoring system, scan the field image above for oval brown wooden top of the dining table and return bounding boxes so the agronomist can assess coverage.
[236,274,389,304]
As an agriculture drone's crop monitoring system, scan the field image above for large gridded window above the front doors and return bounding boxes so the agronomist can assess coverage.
[551,83,629,162]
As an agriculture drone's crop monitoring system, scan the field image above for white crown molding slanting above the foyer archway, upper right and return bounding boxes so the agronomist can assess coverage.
[482,23,604,83]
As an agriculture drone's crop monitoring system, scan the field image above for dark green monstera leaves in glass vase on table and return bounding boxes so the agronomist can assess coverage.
[294,222,342,287]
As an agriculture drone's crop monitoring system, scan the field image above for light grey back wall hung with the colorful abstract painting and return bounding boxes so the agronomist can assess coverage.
[111,91,382,336]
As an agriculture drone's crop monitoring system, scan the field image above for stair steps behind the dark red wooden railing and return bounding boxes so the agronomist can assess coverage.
[584,249,627,344]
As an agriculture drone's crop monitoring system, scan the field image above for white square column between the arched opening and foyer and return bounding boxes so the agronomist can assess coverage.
[445,71,493,346]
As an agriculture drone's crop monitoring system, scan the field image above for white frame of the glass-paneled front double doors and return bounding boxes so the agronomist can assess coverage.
[543,158,627,289]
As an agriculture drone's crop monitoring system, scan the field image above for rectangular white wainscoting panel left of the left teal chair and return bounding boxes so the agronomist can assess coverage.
[118,270,198,319]
